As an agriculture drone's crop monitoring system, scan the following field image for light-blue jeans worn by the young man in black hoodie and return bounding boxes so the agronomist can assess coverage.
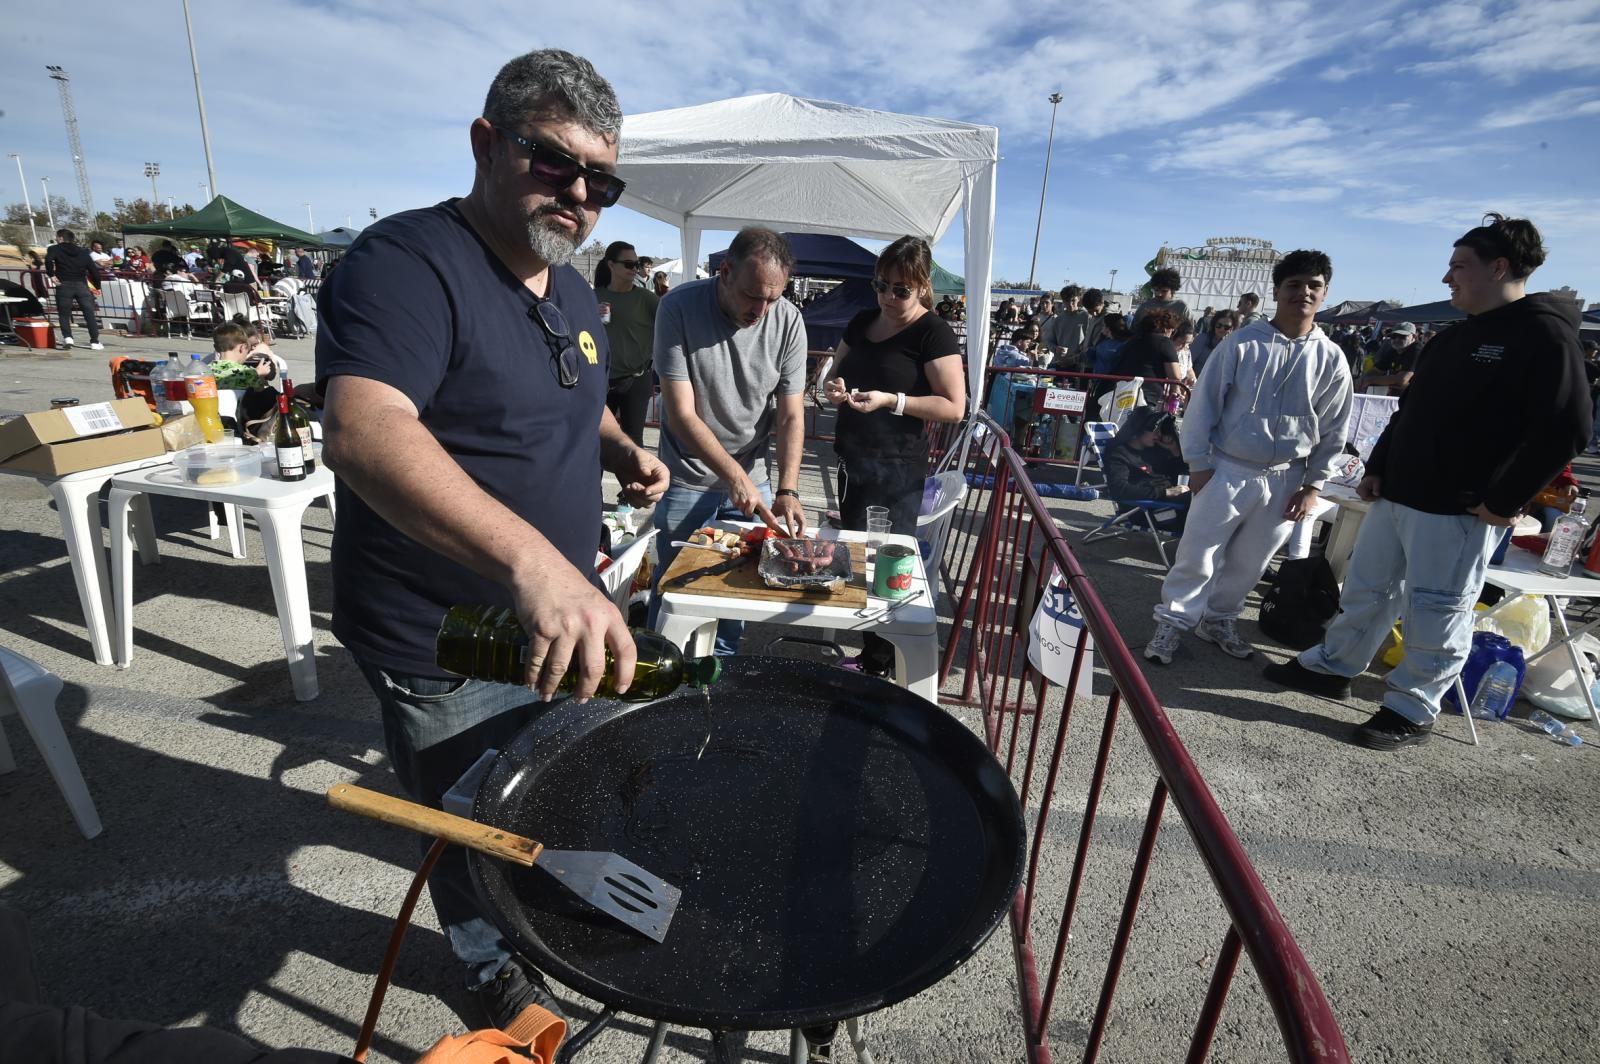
[1299,499,1502,725]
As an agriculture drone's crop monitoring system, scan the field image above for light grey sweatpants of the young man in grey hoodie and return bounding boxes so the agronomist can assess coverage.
[1155,459,1306,632]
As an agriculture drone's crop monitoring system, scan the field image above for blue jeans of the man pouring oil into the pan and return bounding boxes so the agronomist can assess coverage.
[357,659,547,987]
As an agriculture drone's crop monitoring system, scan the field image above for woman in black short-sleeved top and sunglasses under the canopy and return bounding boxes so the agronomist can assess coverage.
[824,237,966,675]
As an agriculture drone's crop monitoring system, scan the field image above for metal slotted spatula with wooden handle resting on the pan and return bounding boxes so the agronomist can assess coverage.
[328,784,683,942]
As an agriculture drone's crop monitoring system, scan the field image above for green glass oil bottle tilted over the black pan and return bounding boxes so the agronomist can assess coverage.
[435,606,722,702]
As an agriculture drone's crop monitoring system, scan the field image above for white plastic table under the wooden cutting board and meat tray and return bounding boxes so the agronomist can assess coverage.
[656,528,939,702]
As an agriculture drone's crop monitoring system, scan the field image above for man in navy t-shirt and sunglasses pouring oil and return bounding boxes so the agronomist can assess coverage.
[317,50,669,1027]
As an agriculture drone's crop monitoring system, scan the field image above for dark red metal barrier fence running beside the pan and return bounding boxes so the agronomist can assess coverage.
[941,414,1349,1064]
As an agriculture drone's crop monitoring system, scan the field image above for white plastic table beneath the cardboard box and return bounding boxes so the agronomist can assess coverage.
[0,454,171,666]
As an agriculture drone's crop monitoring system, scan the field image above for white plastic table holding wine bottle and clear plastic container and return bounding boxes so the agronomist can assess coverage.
[109,464,334,702]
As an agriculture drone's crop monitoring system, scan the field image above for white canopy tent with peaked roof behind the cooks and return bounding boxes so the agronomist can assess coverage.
[618,93,1000,406]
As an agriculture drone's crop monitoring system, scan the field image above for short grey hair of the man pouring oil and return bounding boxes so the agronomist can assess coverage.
[483,48,622,141]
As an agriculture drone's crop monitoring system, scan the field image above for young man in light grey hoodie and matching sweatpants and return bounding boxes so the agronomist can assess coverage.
[1144,251,1352,666]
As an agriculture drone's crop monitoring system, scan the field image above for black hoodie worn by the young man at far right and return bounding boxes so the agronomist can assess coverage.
[1366,293,1590,517]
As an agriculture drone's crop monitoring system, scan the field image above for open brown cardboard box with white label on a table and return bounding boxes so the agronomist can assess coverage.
[0,397,166,477]
